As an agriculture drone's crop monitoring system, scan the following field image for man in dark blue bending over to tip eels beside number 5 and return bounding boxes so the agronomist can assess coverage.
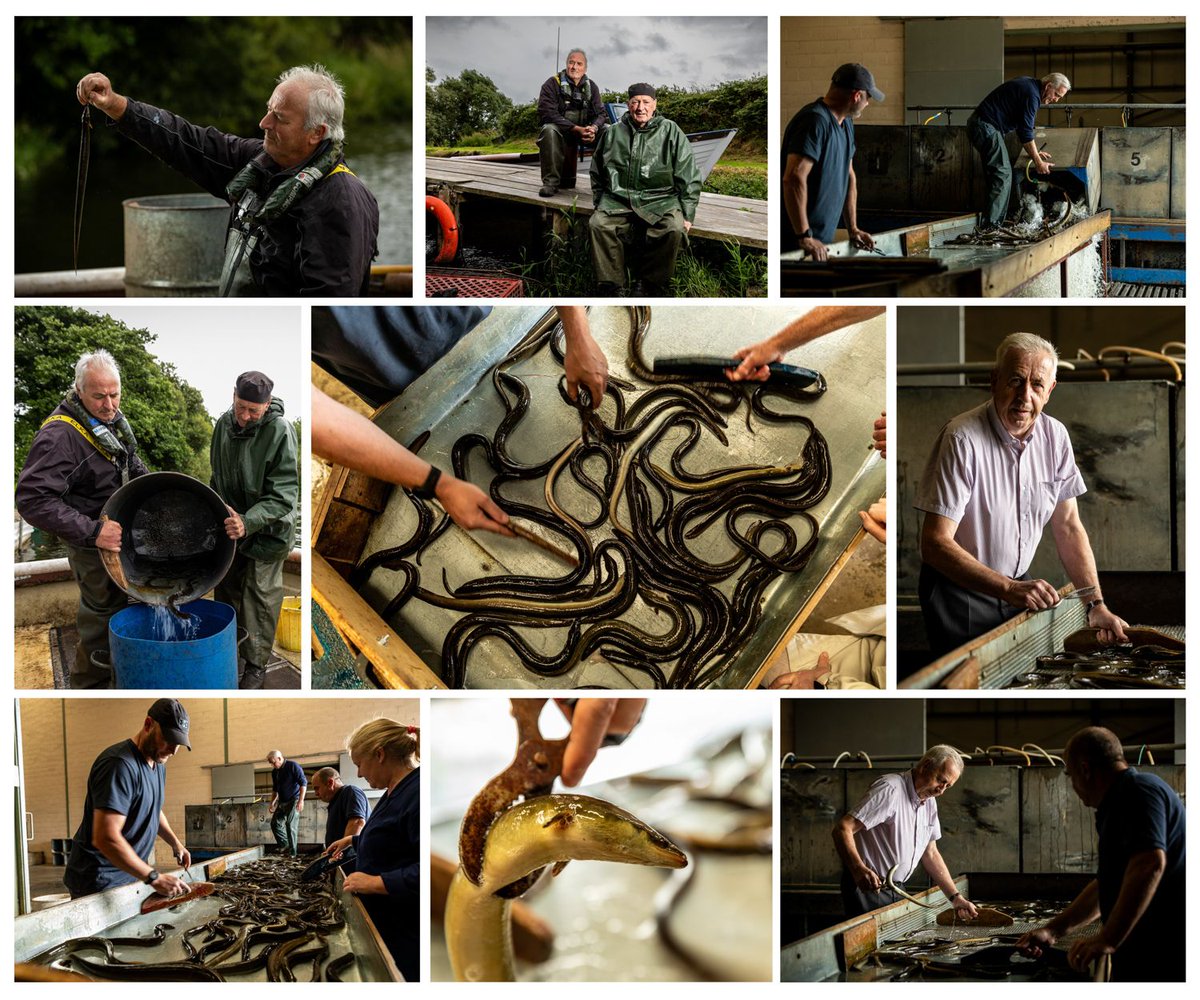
[967,73,1070,233]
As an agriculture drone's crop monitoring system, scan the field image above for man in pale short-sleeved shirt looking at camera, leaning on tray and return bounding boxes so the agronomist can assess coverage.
[913,333,1128,655]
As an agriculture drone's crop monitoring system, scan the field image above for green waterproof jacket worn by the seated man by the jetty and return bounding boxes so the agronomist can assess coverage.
[592,112,701,223]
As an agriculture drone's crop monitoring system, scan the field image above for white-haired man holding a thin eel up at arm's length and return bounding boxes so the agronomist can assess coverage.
[76,65,379,297]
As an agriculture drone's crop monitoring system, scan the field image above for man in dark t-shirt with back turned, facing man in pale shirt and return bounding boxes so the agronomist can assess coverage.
[1018,726,1187,982]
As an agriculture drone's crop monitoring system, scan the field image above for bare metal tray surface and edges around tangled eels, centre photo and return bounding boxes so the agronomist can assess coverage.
[350,306,886,688]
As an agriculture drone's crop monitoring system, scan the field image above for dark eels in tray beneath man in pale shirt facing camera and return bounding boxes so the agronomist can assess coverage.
[1009,628,1187,689]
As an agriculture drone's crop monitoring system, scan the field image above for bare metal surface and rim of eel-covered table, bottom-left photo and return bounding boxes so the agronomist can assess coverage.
[13,848,401,982]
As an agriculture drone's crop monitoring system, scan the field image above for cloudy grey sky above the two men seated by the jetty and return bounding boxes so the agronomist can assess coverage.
[425,17,767,100]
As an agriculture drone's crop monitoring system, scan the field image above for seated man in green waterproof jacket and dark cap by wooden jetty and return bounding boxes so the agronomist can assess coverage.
[588,83,701,295]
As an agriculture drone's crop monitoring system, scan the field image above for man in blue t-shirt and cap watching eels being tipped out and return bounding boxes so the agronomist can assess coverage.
[781,62,883,261]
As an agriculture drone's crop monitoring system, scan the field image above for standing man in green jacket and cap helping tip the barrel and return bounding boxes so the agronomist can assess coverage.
[209,371,300,689]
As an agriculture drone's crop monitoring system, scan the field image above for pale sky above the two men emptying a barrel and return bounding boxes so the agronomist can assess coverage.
[91,299,305,420]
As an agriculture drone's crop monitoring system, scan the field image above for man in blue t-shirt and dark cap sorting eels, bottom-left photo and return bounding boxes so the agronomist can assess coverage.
[62,697,192,899]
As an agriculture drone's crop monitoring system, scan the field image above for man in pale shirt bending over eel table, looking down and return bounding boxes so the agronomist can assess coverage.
[833,743,978,918]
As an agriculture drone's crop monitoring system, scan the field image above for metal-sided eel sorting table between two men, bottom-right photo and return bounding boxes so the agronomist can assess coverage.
[780,873,1099,982]
